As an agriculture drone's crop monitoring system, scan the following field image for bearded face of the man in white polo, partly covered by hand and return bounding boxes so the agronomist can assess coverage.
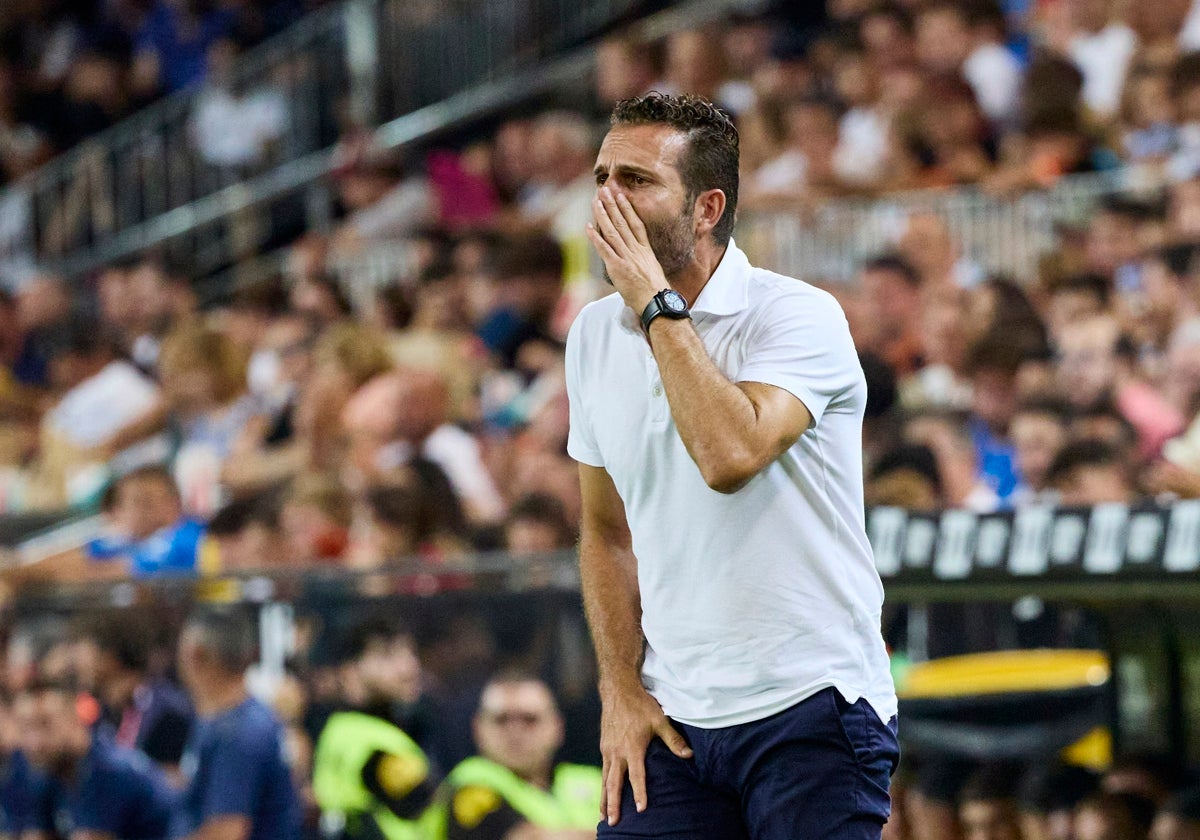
[595,125,696,280]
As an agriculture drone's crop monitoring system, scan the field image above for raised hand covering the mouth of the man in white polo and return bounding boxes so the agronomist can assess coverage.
[587,186,671,316]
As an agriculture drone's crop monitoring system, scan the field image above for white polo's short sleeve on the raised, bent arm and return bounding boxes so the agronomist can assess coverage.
[736,288,862,426]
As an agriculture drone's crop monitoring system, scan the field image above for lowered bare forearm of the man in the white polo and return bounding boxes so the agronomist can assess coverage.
[580,533,644,696]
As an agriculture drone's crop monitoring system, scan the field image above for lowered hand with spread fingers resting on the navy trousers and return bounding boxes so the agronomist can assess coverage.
[600,685,691,826]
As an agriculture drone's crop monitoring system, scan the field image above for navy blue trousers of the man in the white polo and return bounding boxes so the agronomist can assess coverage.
[598,689,900,840]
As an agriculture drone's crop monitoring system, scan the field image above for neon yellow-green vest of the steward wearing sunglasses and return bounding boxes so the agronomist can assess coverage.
[422,757,604,840]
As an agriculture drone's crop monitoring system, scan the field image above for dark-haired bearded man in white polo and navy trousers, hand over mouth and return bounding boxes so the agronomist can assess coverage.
[566,88,898,840]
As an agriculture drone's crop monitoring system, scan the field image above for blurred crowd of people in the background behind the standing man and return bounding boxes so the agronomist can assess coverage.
[0,0,1200,840]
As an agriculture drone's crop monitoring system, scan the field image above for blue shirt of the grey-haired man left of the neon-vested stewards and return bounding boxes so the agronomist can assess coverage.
[175,698,301,840]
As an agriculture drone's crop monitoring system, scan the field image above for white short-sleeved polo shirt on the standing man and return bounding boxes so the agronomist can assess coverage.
[566,242,896,728]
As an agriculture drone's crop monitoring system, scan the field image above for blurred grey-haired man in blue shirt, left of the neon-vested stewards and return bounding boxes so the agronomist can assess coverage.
[174,608,301,840]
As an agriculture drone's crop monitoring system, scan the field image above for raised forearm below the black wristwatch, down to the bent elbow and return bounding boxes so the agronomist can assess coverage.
[650,318,761,492]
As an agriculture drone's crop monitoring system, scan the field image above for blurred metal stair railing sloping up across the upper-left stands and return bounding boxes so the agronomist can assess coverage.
[0,0,686,286]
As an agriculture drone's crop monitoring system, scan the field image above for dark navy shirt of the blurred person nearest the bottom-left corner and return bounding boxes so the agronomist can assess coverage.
[32,737,176,840]
